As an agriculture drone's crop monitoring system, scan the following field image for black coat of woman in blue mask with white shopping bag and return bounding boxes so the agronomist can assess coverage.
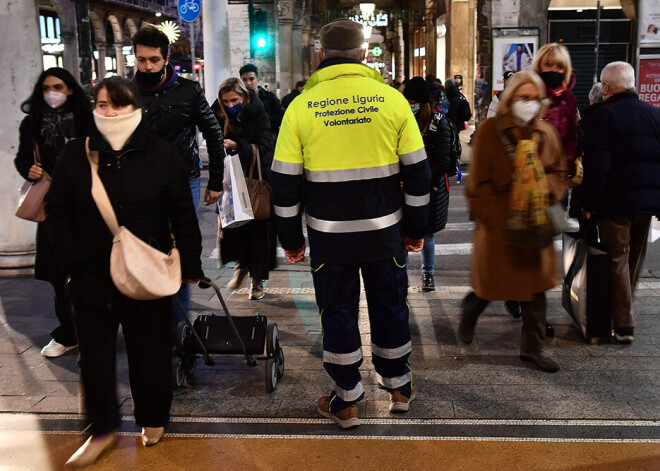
[211,92,277,280]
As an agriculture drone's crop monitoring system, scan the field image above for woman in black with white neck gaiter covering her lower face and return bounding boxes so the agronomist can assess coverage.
[46,77,204,466]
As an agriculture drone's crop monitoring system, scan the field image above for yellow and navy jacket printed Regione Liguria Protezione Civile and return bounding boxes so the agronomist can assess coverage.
[272,59,430,263]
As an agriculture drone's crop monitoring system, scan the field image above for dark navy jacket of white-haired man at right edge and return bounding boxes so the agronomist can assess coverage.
[580,92,660,217]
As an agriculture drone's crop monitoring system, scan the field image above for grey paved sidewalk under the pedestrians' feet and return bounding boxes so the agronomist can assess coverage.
[0,196,660,428]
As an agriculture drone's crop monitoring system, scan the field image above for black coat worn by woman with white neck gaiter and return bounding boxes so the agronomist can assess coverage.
[46,119,203,308]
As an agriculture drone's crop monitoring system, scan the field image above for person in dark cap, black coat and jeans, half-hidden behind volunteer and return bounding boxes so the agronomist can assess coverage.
[403,77,452,291]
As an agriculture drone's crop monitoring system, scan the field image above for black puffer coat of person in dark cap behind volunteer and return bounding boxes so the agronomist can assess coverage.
[423,111,452,234]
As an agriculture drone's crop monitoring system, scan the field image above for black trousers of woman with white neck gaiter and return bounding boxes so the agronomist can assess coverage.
[75,296,172,435]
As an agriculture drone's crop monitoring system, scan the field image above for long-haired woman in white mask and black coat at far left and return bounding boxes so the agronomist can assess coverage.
[14,67,92,357]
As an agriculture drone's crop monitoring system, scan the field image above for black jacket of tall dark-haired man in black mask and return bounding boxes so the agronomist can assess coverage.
[133,64,225,191]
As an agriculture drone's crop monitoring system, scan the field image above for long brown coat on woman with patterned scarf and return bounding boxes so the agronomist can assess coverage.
[465,113,568,301]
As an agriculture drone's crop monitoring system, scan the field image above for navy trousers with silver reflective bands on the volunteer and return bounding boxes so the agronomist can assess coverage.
[312,251,412,412]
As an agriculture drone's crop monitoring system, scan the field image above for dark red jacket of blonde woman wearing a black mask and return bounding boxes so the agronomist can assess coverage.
[543,75,578,175]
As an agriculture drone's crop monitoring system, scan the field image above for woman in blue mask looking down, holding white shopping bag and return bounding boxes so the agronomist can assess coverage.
[211,78,276,299]
